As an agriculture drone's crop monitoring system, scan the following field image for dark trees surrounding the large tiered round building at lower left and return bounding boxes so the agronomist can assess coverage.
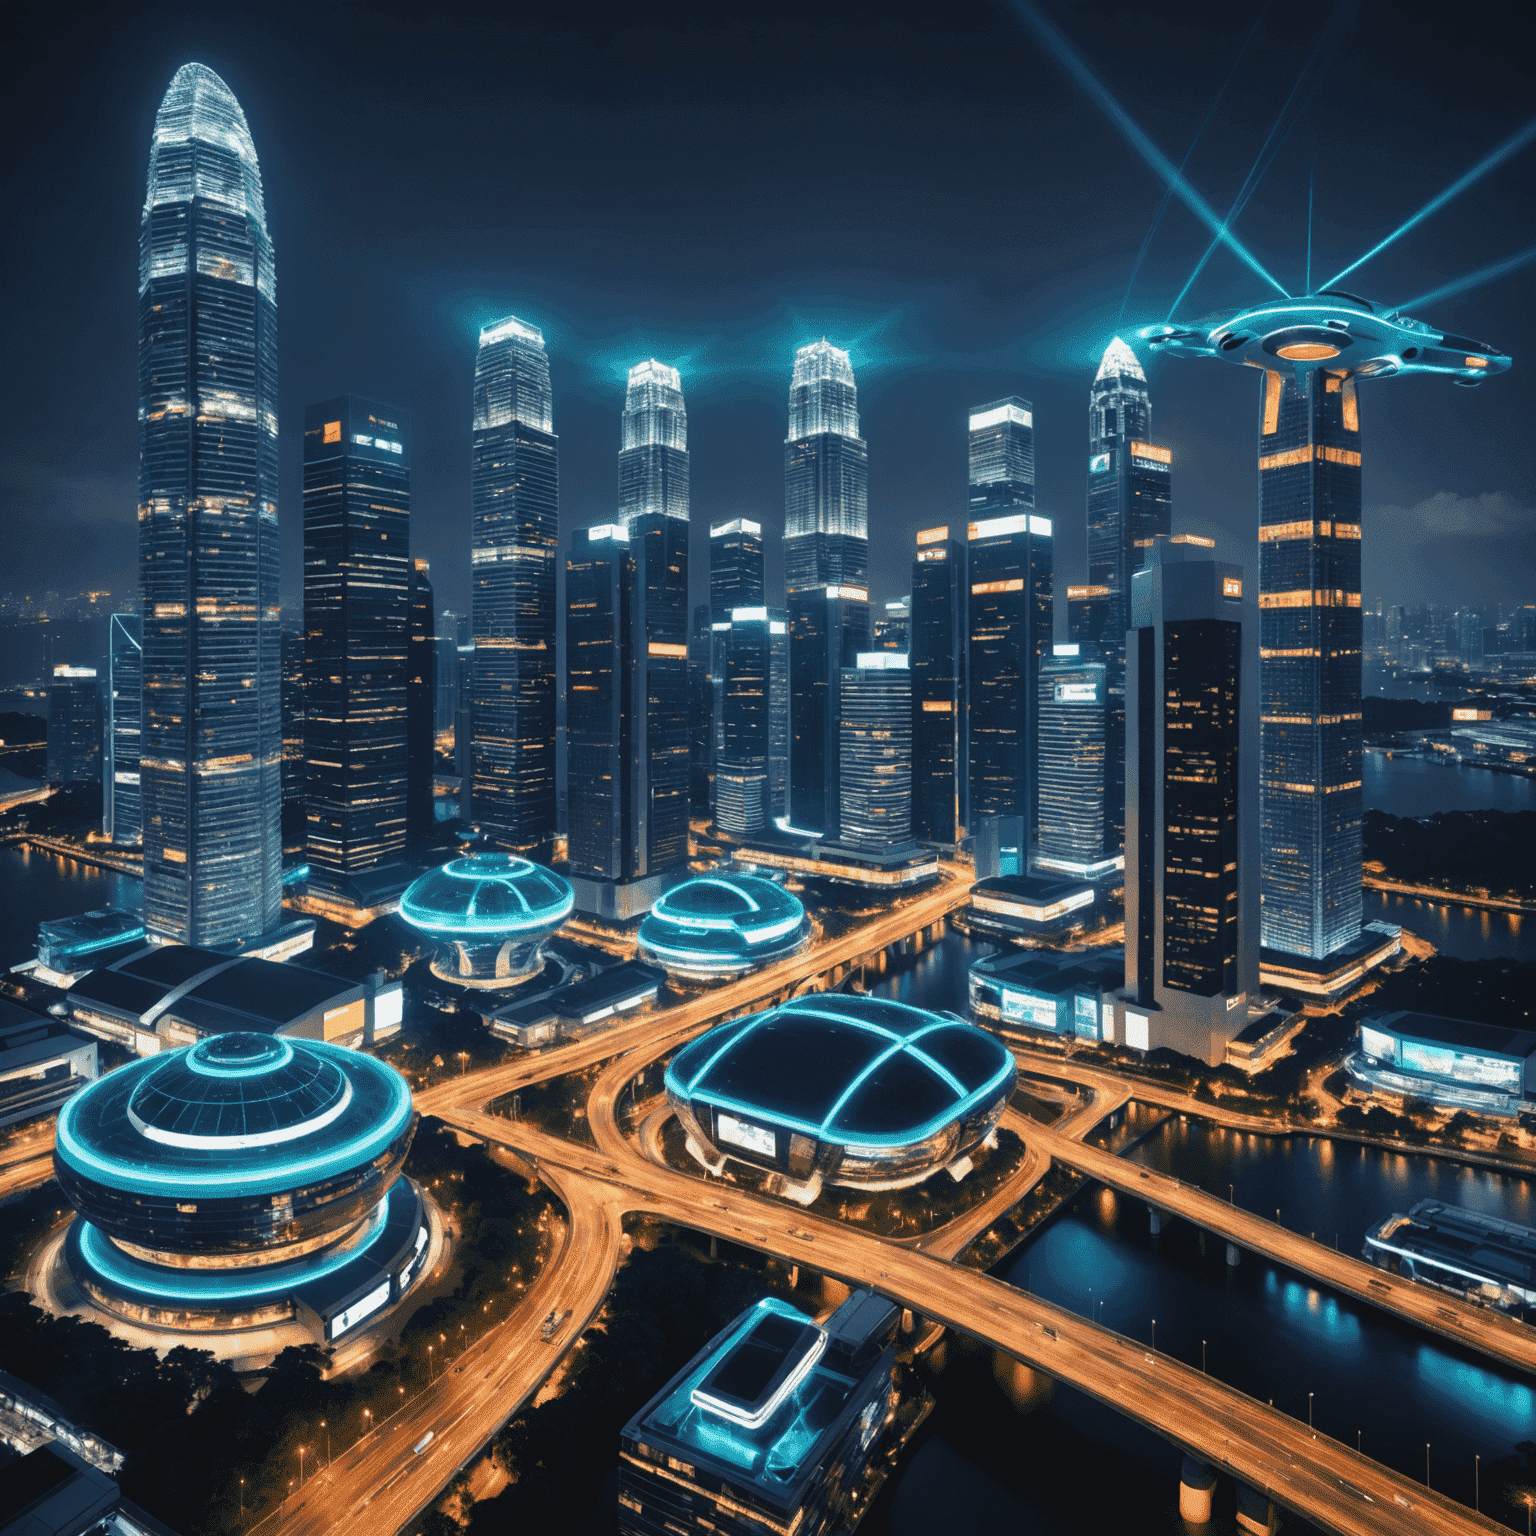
[0,1120,553,1536]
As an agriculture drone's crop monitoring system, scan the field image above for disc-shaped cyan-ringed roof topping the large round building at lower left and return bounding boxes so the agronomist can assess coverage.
[54,1034,413,1209]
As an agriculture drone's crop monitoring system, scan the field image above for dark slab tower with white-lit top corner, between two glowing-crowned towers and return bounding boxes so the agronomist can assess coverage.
[565,524,634,880]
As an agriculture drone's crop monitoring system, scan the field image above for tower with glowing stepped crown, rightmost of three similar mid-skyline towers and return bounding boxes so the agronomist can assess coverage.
[783,339,869,837]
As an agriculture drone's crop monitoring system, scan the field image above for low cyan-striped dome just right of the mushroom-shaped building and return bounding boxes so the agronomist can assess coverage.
[639,872,811,982]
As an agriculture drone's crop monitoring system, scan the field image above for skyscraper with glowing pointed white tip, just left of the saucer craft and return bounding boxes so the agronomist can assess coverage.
[1087,336,1174,860]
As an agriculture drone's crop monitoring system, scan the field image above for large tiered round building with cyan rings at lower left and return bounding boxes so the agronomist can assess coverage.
[54,1032,430,1342]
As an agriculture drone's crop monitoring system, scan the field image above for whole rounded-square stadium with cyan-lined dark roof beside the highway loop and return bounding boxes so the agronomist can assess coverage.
[667,994,1017,1203]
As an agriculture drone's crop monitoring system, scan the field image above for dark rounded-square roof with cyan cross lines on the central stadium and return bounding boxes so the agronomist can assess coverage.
[667,994,1017,1150]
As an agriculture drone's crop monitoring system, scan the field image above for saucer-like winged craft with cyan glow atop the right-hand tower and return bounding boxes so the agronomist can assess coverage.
[1138,289,1510,389]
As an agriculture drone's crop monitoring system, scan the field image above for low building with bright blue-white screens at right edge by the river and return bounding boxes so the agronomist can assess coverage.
[1346,1011,1536,1115]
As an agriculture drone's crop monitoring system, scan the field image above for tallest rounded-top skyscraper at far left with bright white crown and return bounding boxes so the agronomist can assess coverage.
[138,65,283,946]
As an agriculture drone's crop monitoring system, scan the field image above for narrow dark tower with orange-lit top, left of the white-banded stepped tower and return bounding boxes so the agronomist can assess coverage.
[911,527,971,848]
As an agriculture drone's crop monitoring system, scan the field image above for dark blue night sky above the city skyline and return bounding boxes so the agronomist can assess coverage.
[0,0,1536,610]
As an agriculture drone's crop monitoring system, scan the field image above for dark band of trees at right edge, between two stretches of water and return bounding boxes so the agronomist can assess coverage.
[1364,811,1536,899]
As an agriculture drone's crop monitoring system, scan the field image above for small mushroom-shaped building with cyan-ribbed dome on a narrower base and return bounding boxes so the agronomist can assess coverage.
[399,854,576,986]
